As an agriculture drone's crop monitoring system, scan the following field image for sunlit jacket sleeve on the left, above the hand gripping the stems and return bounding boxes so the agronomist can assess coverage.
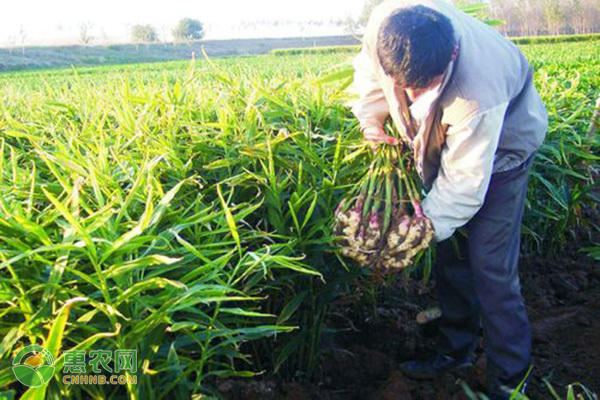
[352,44,389,130]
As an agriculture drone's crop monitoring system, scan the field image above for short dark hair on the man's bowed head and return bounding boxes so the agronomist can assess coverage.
[377,6,454,88]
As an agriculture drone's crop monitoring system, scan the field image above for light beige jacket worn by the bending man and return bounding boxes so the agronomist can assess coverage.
[352,0,547,241]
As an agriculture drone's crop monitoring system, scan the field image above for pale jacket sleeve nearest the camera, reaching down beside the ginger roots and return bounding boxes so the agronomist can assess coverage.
[422,103,508,242]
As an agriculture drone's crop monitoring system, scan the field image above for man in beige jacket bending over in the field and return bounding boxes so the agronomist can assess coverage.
[352,0,547,399]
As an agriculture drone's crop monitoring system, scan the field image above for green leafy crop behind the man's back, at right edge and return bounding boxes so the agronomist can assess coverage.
[524,41,600,252]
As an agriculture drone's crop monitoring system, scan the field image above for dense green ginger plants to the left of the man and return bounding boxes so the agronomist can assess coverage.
[0,54,360,399]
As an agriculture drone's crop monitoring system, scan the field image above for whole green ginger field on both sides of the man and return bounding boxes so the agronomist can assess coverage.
[0,41,600,399]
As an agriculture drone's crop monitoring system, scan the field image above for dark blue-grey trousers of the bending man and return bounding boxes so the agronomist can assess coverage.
[434,154,535,385]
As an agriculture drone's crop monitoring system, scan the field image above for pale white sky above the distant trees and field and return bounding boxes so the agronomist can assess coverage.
[0,0,365,46]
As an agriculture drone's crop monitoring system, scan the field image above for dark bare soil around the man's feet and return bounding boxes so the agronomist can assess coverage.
[218,241,600,400]
